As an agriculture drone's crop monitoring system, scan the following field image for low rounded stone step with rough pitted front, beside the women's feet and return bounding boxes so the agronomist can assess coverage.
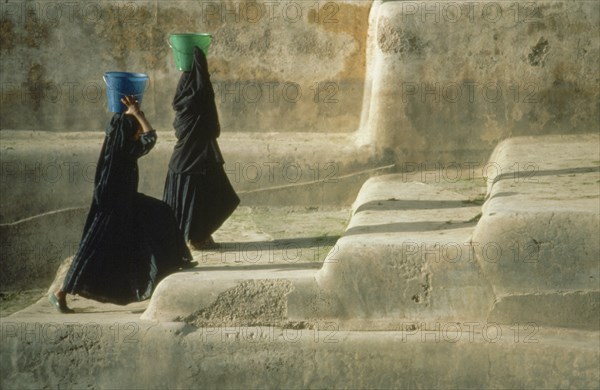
[141,263,320,326]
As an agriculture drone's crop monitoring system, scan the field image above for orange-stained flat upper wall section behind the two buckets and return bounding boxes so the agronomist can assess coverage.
[0,0,371,132]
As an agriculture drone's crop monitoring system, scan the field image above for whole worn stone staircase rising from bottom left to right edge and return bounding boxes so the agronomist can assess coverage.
[0,135,600,389]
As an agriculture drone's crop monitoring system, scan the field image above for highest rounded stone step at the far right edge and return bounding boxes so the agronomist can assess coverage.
[473,133,600,330]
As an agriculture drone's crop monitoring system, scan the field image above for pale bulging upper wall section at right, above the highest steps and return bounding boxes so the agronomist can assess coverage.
[359,0,600,163]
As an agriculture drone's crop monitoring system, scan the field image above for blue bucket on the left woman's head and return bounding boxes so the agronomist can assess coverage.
[103,72,148,112]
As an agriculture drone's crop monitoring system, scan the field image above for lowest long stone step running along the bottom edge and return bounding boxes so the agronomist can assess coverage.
[0,314,600,389]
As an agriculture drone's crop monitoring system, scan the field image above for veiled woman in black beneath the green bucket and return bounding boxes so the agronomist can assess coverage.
[163,47,240,249]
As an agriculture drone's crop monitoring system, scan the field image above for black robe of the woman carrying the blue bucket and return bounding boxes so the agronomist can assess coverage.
[63,114,192,305]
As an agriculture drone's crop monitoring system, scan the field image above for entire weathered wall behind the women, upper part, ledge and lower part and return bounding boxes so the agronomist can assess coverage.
[0,0,600,296]
